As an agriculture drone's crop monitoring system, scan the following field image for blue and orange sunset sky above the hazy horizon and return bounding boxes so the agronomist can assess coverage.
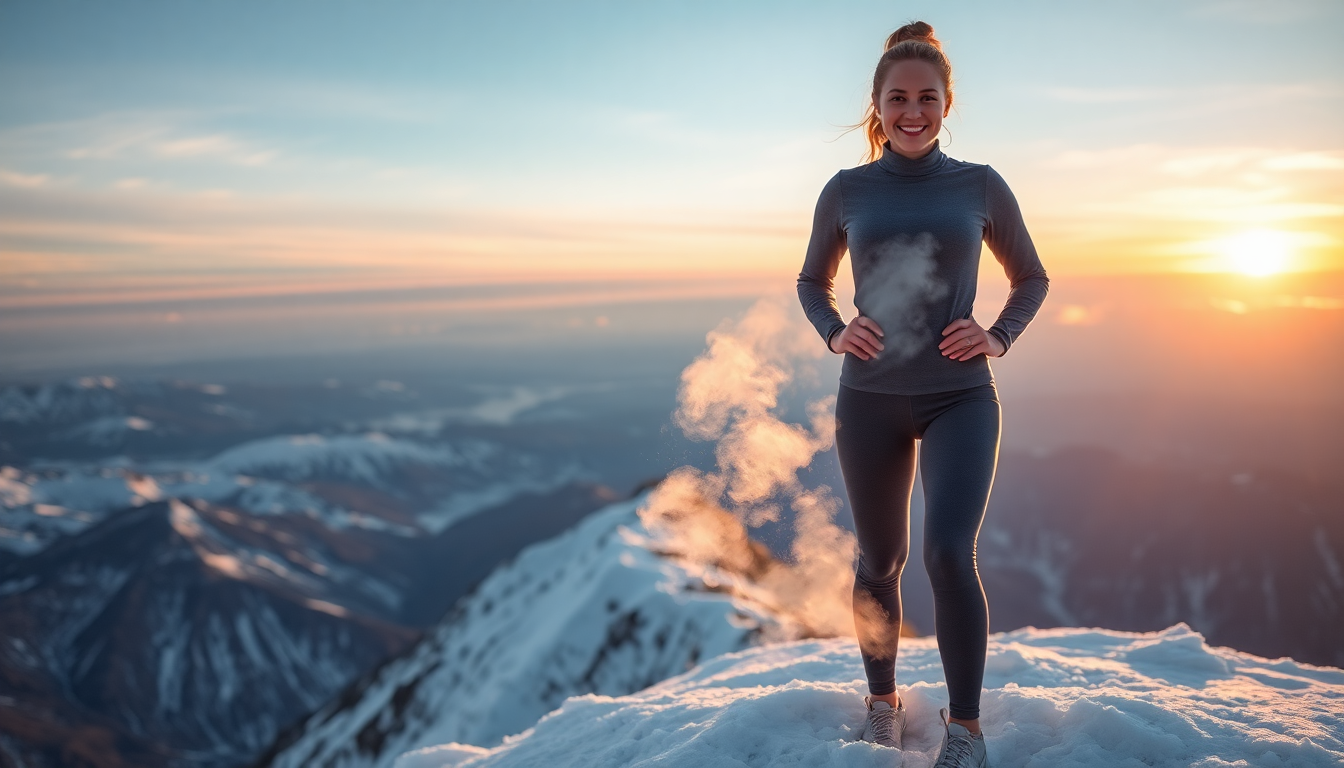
[0,1,1344,308]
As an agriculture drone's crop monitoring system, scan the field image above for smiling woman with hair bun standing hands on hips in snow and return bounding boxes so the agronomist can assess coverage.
[798,22,1050,767]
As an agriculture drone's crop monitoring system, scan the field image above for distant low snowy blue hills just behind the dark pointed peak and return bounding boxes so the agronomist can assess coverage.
[0,432,582,555]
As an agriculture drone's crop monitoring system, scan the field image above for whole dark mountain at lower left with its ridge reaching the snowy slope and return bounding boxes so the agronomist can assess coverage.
[0,469,612,768]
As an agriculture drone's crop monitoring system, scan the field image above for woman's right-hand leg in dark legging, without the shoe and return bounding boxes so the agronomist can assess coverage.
[919,395,1001,721]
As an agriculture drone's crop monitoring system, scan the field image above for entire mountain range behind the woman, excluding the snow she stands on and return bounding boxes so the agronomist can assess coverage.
[0,378,1344,768]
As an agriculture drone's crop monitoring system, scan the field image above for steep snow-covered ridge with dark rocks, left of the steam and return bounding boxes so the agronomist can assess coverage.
[259,499,801,768]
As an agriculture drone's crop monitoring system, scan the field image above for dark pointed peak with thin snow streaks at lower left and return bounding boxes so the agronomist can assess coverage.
[0,499,419,767]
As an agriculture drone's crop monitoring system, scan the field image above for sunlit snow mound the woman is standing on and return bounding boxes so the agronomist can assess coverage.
[395,624,1344,768]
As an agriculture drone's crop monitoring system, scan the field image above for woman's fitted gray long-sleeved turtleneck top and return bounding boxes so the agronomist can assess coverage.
[798,141,1050,395]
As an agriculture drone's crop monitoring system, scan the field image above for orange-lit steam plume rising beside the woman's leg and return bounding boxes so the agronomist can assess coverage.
[640,299,884,636]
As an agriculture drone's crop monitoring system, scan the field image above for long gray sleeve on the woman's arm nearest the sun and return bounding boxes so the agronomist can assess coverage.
[978,168,1050,352]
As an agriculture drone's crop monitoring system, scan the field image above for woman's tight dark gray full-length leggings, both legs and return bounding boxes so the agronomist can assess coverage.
[836,383,1000,720]
